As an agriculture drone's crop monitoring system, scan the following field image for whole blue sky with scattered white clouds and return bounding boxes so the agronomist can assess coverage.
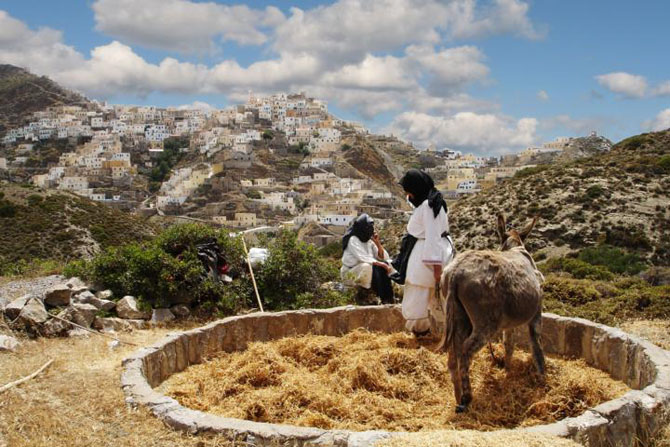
[0,0,670,156]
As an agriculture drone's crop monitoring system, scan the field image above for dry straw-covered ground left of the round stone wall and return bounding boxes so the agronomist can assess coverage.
[0,329,230,447]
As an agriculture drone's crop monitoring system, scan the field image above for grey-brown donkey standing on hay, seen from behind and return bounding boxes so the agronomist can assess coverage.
[441,214,545,413]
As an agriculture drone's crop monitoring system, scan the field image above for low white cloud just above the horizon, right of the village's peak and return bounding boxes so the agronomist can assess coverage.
[386,112,538,155]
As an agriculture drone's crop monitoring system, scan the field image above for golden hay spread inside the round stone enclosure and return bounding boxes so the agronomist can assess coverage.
[161,330,628,431]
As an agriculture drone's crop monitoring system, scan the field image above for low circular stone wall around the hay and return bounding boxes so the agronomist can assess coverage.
[121,306,670,447]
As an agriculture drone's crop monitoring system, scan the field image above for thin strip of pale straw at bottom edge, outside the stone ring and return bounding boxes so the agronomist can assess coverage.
[375,430,579,447]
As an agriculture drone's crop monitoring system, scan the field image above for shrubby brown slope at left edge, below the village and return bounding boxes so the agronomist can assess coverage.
[0,184,154,267]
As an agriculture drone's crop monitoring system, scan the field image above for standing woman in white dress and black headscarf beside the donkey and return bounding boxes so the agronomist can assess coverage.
[396,169,454,336]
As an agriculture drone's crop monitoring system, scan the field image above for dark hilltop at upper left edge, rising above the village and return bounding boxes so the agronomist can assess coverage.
[0,64,89,136]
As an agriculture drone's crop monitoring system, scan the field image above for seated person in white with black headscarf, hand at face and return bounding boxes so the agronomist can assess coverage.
[340,214,395,304]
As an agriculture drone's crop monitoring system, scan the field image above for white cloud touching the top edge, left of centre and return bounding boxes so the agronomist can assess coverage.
[92,0,285,53]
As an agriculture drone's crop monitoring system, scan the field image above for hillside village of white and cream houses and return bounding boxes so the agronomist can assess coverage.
[0,75,611,245]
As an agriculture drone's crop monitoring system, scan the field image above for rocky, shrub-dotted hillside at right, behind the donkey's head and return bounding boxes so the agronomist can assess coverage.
[450,131,670,265]
